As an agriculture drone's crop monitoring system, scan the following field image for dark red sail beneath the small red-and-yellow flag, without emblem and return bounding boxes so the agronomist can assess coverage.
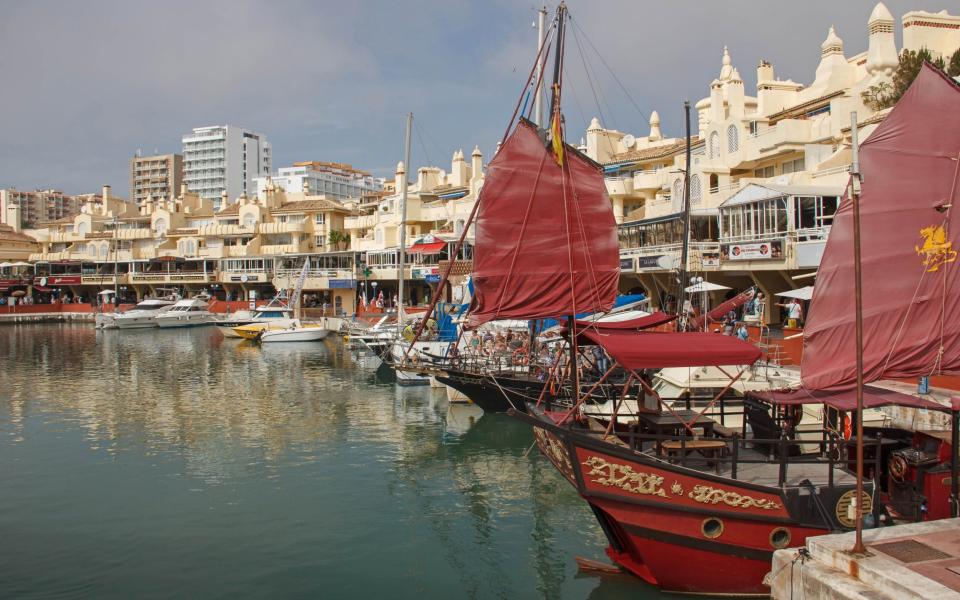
[468,121,620,327]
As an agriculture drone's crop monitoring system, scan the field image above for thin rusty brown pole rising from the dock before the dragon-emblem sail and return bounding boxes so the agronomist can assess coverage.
[850,111,867,554]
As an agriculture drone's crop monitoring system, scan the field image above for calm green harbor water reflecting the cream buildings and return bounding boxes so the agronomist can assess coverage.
[0,323,661,599]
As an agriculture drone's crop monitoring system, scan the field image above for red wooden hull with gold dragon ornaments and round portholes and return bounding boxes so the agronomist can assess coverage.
[516,413,868,596]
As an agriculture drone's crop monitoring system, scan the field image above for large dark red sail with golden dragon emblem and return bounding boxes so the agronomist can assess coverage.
[801,65,960,390]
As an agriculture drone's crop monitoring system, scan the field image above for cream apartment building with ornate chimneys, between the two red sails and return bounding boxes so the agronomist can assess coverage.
[587,3,960,320]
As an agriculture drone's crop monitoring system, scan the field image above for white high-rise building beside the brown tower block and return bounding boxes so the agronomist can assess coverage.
[183,125,271,209]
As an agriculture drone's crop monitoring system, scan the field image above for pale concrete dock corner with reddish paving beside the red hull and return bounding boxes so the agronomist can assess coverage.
[770,519,960,600]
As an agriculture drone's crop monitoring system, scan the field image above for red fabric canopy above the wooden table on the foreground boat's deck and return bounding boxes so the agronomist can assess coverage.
[577,327,761,369]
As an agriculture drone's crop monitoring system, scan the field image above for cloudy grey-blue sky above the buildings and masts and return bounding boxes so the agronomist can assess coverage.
[0,0,960,196]
